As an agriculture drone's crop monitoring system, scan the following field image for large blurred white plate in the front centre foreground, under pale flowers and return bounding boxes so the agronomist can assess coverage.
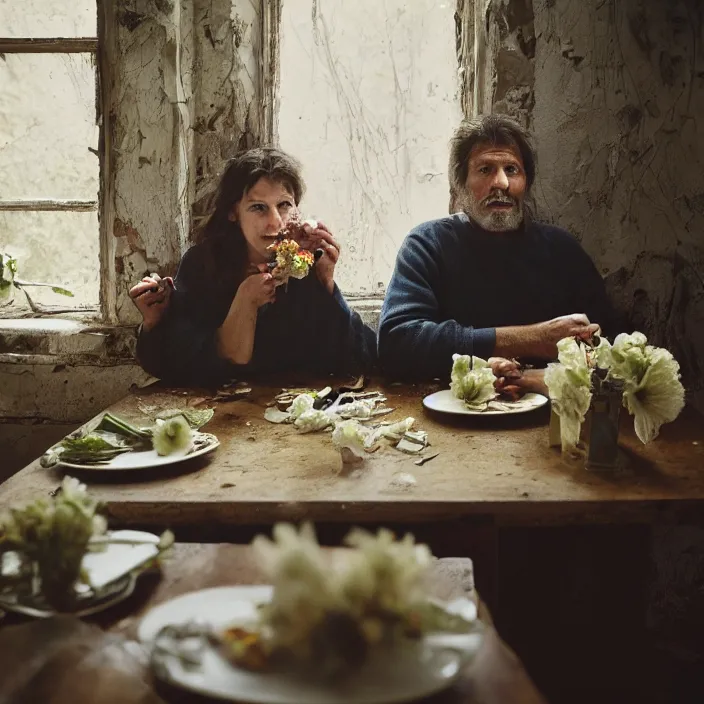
[139,586,482,704]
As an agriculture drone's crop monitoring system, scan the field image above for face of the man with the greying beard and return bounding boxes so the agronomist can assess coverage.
[462,144,526,232]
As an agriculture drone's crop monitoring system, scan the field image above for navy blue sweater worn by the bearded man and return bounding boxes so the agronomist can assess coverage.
[378,213,614,378]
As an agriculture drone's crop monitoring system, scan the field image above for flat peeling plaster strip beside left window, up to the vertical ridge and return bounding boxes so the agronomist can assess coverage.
[105,0,192,324]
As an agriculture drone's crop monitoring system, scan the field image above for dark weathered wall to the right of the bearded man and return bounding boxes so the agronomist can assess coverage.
[480,0,704,409]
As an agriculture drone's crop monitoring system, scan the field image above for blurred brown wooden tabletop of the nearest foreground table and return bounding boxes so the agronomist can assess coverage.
[0,544,544,704]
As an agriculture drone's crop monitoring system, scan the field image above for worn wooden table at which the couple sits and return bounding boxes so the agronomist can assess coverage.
[0,383,704,528]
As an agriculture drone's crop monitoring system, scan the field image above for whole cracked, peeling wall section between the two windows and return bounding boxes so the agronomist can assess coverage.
[104,0,260,324]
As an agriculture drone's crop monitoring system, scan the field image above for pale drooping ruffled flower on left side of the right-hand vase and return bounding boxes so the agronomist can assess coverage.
[545,337,592,452]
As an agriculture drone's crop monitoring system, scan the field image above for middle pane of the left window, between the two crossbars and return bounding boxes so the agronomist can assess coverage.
[0,53,99,200]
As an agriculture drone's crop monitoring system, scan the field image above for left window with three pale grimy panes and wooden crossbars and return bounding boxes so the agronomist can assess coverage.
[0,0,100,313]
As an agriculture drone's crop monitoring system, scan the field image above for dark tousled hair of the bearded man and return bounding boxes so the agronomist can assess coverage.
[448,115,535,217]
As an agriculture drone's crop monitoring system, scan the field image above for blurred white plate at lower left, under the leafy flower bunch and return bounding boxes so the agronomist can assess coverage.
[0,530,159,618]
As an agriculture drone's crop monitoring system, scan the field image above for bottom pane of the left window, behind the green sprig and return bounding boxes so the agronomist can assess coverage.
[0,211,100,307]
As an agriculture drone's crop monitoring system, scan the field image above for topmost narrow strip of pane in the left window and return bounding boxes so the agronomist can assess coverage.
[0,0,98,38]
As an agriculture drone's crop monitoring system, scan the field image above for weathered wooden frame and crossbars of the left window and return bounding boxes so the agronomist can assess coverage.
[0,31,106,319]
